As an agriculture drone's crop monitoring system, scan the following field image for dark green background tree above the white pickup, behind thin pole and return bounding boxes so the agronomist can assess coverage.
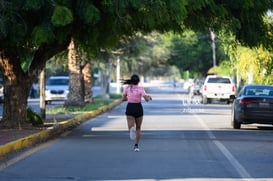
[167,31,225,76]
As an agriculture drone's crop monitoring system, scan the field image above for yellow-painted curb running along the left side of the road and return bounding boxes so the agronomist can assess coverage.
[0,100,122,159]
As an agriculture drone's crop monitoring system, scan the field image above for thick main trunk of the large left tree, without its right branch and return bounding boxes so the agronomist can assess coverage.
[0,52,34,129]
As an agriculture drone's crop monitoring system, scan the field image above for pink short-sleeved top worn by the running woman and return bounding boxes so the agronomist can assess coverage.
[123,85,147,103]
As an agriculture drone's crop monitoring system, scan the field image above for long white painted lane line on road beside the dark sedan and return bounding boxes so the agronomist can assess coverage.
[193,114,252,180]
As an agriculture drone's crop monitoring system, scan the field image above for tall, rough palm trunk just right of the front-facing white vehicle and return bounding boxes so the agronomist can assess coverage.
[65,39,84,106]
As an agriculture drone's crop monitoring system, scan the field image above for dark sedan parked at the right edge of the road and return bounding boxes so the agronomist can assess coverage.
[231,85,273,129]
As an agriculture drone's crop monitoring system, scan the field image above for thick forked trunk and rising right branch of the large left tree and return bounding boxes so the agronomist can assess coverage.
[0,41,69,129]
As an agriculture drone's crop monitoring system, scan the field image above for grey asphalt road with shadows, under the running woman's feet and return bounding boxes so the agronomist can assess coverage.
[0,89,273,181]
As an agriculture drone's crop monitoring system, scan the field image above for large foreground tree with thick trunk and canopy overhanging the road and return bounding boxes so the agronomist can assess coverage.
[0,0,273,128]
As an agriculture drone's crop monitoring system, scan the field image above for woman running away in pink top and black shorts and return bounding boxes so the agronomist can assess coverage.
[122,74,152,152]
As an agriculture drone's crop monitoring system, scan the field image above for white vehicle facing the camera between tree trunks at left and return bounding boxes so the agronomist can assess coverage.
[45,76,69,104]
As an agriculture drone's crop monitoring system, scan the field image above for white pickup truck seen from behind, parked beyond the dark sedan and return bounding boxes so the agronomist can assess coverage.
[202,75,236,104]
